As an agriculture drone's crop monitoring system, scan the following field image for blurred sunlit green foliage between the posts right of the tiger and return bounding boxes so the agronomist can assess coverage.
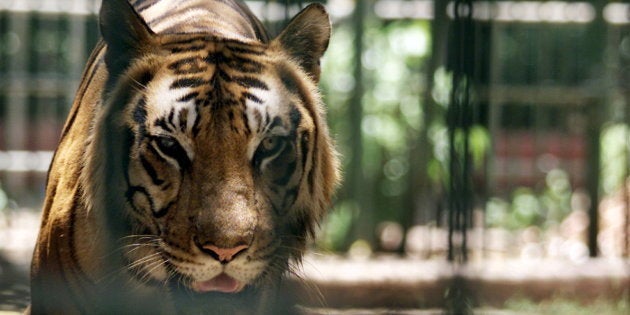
[320,8,630,250]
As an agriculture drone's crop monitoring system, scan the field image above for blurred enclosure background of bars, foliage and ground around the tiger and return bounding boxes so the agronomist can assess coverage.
[0,0,630,314]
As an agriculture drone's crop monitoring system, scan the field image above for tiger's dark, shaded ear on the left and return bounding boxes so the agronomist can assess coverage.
[99,0,155,71]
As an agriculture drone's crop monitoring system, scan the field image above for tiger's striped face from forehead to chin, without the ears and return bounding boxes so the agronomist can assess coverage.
[126,38,317,292]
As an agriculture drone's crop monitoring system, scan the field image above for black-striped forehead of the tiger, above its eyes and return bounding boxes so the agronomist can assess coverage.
[135,38,282,136]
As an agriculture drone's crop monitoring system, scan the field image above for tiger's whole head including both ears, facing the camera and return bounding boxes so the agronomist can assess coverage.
[88,1,338,310]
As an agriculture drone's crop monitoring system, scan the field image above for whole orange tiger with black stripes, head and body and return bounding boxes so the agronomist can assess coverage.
[25,0,341,314]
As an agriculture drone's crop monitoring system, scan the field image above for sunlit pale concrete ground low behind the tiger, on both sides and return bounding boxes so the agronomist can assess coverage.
[0,210,630,315]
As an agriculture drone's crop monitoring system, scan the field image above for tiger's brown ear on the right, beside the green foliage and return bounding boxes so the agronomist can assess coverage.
[274,3,331,82]
